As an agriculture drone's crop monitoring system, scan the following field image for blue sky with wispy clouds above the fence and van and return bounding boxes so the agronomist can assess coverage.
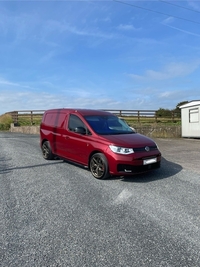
[0,0,200,114]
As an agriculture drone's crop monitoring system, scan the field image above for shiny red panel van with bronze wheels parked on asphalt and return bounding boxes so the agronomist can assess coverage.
[40,109,161,179]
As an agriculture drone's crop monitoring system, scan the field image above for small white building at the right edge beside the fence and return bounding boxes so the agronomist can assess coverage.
[179,100,200,138]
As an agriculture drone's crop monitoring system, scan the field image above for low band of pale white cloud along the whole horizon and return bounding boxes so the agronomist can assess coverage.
[0,86,199,115]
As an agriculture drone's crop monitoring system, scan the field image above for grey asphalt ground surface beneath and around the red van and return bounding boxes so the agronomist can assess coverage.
[0,133,200,267]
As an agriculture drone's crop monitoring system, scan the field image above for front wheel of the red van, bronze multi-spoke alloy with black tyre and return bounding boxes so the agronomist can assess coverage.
[90,153,110,179]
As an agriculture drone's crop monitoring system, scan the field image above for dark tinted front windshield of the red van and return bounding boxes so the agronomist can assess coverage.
[84,115,135,135]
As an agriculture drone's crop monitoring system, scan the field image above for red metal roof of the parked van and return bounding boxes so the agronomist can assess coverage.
[45,108,114,116]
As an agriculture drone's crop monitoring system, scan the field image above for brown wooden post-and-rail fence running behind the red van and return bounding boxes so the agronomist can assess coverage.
[7,109,181,125]
